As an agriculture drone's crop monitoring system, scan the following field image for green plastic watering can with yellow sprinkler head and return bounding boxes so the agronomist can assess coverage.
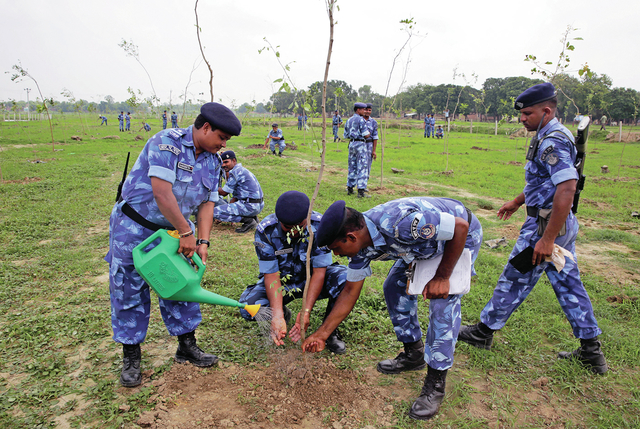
[133,229,260,317]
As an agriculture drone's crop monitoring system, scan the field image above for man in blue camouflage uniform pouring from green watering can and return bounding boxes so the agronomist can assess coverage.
[105,103,241,387]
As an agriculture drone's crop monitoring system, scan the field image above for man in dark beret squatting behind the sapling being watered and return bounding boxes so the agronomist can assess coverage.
[239,191,347,354]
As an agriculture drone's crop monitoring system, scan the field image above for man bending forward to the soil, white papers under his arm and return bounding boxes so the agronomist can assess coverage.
[302,197,482,420]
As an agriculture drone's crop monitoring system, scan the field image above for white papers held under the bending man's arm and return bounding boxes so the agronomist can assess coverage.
[407,249,471,295]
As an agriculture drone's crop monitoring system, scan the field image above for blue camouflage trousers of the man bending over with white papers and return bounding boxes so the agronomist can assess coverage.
[382,216,482,371]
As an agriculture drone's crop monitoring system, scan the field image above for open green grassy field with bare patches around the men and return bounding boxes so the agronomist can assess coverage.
[0,115,640,429]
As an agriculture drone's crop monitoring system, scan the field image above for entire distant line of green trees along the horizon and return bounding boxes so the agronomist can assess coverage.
[0,73,640,122]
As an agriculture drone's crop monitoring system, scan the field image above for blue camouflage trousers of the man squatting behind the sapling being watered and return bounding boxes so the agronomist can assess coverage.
[238,263,347,321]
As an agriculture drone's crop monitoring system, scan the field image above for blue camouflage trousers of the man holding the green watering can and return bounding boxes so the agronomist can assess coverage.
[105,206,202,344]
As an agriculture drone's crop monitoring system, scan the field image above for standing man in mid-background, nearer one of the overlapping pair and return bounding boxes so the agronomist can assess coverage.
[344,103,371,198]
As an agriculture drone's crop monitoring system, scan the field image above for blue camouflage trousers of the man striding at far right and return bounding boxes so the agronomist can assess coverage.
[480,214,602,339]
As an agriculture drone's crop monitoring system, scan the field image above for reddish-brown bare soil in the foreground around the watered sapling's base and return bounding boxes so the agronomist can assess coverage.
[137,350,400,429]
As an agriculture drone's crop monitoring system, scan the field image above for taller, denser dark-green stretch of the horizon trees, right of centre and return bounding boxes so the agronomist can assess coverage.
[262,73,640,122]
